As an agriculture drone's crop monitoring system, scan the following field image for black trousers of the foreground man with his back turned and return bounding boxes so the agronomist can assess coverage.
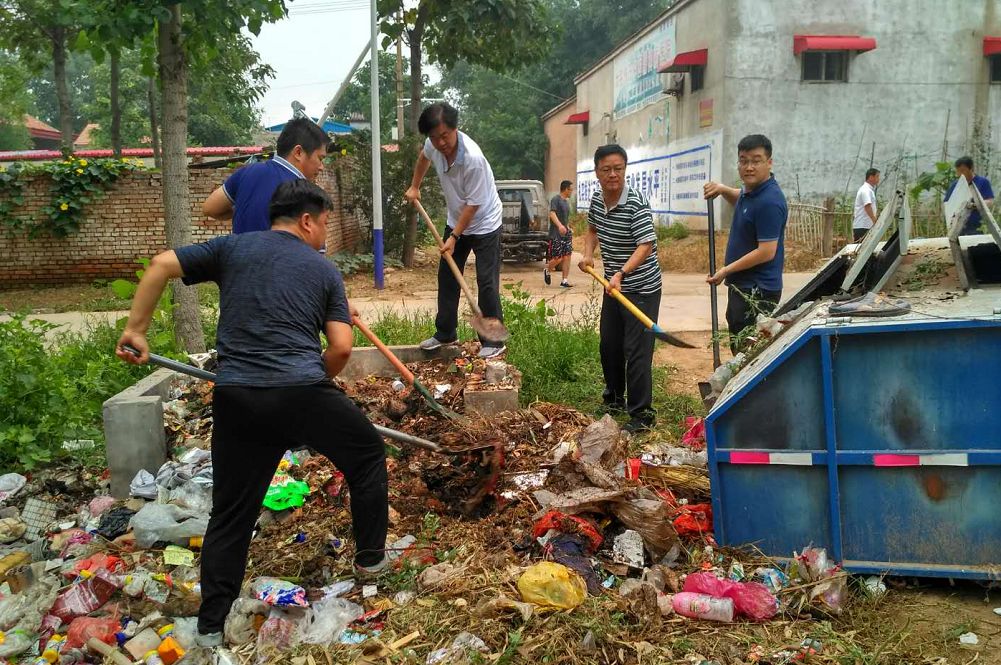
[198,383,389,634]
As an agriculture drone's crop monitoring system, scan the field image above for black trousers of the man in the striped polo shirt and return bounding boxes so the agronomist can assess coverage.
[599,290,661,422]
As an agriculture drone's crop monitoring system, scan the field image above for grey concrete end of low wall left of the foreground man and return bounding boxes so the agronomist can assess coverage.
[102,370,176,499]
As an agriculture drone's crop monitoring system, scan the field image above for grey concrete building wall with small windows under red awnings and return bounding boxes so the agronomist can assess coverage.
[718,0,1001,200]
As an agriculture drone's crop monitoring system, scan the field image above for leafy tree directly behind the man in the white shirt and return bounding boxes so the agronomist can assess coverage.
[376,0,549,266]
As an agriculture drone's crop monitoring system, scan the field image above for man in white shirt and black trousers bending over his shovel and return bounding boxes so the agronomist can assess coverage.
[403,102,506,358]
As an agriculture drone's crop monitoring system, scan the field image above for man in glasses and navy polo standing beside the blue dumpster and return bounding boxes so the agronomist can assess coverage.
[704,134,789,355]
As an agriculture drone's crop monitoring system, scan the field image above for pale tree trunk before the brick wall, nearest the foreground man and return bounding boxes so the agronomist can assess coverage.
[157,4,205,354]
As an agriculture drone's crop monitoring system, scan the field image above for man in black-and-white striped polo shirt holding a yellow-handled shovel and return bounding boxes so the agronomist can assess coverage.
[580,145,661,433]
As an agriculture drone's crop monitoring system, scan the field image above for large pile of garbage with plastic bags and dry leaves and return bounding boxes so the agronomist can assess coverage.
[0,350,868,665]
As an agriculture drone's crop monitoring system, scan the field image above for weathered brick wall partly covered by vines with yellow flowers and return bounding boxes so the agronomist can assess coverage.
[0,165,367,289]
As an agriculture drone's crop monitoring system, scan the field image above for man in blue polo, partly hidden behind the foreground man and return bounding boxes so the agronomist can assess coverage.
[201,118,330,233]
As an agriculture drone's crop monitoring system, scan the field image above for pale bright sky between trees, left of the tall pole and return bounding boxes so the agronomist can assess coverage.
[251,0,370,126]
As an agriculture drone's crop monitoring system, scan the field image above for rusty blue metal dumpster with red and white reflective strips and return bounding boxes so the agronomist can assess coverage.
[706,287,1001,579]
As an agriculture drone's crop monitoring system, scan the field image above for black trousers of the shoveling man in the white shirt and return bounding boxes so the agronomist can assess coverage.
[434,228,504,346]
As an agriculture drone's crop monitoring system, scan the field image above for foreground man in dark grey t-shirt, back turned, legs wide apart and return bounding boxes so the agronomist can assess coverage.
[115,179,388,647]
